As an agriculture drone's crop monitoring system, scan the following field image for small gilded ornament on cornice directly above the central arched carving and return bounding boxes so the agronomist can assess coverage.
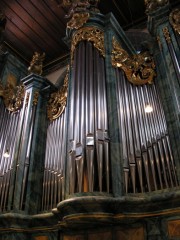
[67,12,89,29]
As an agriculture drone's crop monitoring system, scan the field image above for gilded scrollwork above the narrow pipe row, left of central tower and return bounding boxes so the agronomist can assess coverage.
[47,70,68,121]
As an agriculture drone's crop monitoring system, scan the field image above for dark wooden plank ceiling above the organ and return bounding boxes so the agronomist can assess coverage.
[0,0,179,67]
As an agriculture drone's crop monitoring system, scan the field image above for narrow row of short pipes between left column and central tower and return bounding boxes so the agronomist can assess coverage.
[41,106,67,211]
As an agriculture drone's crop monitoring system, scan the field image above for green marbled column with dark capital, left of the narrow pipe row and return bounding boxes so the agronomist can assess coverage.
[10,74,50,214]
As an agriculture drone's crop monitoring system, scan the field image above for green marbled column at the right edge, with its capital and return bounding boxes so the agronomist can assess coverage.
[148,1,180,180]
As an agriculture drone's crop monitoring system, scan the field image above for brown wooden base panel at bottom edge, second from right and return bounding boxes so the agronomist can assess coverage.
[115,227,145,240]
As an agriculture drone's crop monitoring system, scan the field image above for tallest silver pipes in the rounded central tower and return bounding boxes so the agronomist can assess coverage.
[68,41,110,194]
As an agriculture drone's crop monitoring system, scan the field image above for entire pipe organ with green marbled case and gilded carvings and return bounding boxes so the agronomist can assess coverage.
[0,0,180,239]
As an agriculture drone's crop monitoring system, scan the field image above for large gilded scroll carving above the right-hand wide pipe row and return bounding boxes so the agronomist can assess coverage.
[112,38,156,85]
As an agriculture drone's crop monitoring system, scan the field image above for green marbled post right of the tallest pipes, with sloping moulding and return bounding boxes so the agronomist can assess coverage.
[105,14,135,197]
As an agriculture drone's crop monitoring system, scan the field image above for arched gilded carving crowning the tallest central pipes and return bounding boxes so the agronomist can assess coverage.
[71,27,105,59]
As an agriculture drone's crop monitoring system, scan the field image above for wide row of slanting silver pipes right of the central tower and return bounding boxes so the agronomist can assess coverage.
[115,69,178,193]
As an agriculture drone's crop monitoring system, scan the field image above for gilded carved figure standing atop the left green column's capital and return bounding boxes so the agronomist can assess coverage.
[28,52,45,75]
